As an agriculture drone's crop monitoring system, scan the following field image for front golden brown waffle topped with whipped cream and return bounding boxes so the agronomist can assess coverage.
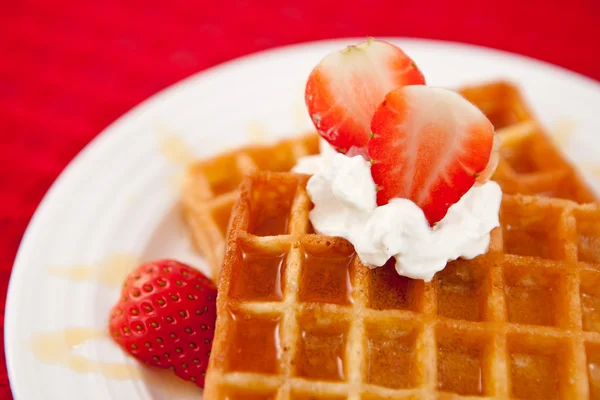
[205,172,600,400]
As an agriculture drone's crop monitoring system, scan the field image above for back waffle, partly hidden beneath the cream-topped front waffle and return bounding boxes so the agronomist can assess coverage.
[183,82,595,276]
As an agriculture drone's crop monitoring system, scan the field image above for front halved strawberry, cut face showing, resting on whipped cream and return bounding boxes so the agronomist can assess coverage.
[369,86,496,224]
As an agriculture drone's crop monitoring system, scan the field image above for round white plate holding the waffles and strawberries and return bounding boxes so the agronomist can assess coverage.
[5,39,600,400]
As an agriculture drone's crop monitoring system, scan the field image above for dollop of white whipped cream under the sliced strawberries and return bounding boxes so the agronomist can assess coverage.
[293,140,502,281]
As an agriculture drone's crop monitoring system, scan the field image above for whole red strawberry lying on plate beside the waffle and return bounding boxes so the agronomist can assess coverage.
[109,260,217,387]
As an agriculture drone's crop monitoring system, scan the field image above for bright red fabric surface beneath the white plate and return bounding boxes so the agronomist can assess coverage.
[0,0,600,399]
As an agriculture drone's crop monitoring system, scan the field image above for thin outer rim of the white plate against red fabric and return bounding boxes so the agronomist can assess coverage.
[3,36,600,398]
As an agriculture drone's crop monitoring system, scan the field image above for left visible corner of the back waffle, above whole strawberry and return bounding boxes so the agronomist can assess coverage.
[182,133,319,277]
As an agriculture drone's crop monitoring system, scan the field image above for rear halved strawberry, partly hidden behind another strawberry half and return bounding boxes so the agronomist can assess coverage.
[305,39,425,153]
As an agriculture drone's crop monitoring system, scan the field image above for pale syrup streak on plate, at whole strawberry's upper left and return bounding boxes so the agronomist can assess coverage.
[46,253,140,287]
